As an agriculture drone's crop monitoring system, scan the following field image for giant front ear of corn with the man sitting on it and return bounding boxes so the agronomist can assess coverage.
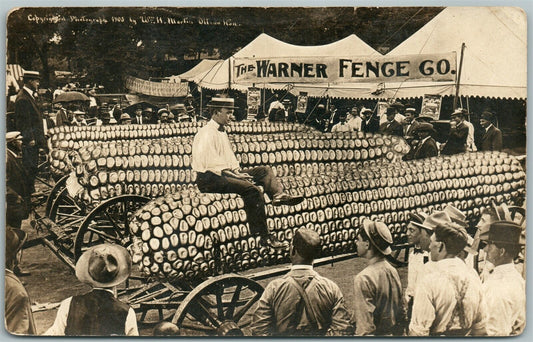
[130,152,525,279]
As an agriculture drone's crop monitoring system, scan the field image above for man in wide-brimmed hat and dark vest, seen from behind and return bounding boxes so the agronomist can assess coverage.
[44,243,139,336]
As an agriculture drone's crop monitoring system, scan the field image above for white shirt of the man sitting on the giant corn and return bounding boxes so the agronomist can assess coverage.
[191,120,240,176]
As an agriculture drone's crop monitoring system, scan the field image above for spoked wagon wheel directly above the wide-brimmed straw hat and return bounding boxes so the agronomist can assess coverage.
[74,195,150,260]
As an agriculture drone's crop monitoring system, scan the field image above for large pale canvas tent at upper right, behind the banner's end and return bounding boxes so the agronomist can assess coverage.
[385,7,527,99]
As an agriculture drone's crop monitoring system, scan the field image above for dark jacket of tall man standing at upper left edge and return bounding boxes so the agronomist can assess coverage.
[15,88,46,148]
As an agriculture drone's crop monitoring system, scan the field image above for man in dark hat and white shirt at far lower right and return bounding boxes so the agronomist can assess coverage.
[480,221,526,336]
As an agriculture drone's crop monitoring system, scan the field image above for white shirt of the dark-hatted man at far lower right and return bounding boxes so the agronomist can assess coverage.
[483,263,526,336]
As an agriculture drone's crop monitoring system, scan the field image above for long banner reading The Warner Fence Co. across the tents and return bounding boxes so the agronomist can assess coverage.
[232,52,457,83]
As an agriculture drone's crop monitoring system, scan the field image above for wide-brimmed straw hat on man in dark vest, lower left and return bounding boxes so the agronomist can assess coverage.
[76,243,131,288]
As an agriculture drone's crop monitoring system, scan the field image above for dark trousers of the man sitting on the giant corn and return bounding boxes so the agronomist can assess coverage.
[196,166,283,236]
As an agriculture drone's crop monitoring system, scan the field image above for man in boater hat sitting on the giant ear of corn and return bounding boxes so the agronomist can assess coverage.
[191,97,303,248]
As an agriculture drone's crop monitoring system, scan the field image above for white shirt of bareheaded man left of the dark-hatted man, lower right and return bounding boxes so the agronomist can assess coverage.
[409,258,486,336]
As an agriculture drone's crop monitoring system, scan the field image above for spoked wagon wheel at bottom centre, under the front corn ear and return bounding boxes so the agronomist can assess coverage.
[172,274,264,335]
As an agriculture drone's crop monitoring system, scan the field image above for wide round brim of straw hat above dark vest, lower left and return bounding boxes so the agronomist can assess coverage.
[76,244,131,288]
